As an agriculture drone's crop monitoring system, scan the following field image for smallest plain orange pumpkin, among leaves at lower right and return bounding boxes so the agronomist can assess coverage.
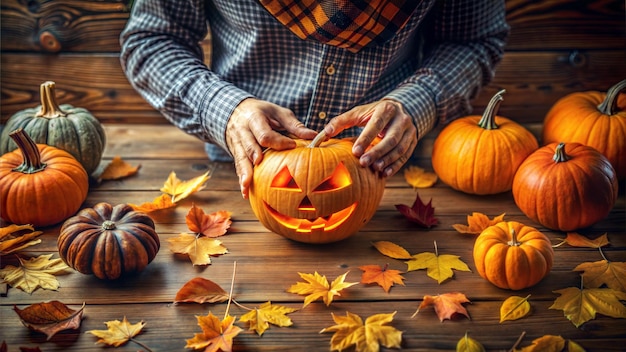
[474,221,554,290]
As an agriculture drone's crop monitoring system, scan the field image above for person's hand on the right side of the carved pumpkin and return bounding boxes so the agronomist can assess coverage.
[324,100,417,176]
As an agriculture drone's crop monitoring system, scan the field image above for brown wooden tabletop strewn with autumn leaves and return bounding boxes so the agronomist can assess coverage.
[0,125,626,351]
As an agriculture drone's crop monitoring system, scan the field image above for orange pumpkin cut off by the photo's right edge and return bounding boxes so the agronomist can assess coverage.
[543,80,626,180]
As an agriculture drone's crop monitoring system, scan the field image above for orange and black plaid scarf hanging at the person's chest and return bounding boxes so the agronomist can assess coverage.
[260,0,420,52]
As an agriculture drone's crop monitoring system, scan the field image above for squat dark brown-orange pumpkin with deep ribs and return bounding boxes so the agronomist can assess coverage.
[57,203,161,280]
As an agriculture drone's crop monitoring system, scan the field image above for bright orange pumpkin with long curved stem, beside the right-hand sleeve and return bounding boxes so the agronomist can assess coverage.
[432,91,539,195]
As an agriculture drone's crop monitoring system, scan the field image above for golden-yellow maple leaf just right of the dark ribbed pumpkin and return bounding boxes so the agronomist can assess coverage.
[167,233,228,265]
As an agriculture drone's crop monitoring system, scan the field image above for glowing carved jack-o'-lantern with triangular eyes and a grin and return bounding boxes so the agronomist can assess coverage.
[250,136,385,243]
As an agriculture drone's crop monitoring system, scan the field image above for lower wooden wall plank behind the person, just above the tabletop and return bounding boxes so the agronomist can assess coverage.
[0,50,626,124]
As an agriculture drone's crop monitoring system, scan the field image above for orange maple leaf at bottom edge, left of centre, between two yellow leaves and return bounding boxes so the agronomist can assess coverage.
[185,312,243,352]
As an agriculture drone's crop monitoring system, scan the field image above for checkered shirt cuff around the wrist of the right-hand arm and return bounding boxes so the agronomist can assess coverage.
[385,77,438,140]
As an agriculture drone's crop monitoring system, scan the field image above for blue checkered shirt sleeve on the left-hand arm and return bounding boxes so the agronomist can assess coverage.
[120,0,251,150]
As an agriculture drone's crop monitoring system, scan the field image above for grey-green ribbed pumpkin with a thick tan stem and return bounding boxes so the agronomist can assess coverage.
[0,81,106,175]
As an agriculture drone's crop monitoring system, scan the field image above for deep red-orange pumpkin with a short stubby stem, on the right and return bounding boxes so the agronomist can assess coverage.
[513,143,618,231]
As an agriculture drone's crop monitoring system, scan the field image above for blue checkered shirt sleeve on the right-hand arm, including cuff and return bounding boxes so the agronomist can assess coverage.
[386,0,509,138]
